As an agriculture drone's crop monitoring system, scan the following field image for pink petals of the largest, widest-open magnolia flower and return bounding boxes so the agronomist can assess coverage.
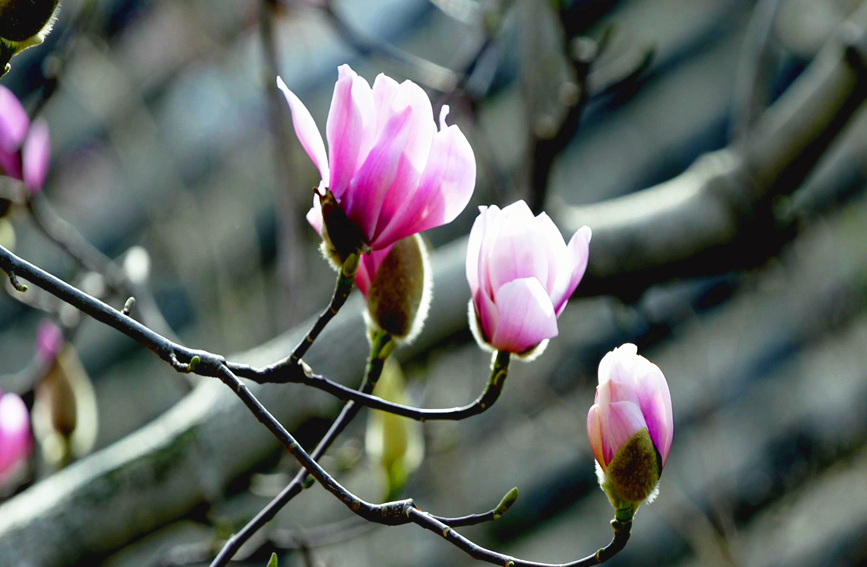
[277,65,476,255]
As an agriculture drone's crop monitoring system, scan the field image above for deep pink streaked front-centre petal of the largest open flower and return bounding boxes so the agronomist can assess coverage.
[341,107,414,243]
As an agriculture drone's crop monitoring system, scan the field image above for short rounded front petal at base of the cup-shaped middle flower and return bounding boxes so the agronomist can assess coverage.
[491,278,557,353]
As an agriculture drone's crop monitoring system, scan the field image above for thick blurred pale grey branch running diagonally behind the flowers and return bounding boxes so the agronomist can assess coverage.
[0,7,867,565]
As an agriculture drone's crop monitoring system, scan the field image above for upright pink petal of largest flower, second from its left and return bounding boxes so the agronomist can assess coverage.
[325,65,376,201]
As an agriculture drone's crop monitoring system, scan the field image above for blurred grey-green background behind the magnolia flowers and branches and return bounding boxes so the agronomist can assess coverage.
[0,0,867,567]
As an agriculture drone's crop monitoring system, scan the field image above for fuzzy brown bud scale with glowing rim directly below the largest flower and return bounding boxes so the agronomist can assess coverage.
[367,234,431,341]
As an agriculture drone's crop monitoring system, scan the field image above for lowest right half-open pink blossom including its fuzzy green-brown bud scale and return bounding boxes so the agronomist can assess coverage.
[587,343,674,513]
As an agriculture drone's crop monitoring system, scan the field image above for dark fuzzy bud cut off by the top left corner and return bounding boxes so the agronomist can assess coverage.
[0,0,59,75]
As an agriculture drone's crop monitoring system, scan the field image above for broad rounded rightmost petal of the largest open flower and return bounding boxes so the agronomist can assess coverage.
[377,118,476,247]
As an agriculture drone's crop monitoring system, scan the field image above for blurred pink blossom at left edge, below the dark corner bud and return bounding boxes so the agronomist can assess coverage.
[0,85,51,194]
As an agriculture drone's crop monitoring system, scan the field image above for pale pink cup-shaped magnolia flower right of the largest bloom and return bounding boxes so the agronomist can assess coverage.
[467,201,591,353]
